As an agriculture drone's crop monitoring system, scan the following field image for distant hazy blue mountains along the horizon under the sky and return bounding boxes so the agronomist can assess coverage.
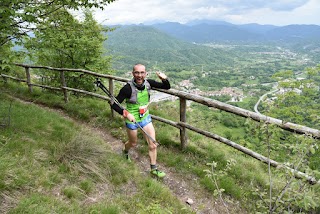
[150,21,320,43]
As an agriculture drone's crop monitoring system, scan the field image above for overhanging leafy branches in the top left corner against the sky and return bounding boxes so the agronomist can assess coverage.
[0,0,115,47]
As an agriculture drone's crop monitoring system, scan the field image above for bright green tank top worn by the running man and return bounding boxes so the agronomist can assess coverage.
[126,87,149,123]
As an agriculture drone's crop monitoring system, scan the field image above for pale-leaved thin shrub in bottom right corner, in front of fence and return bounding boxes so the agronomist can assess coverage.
[254,123,320,214]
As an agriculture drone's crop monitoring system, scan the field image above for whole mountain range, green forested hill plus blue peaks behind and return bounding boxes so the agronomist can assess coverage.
[105,21,320,69]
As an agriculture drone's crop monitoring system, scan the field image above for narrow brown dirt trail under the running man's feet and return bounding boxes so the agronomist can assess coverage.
[11,99,238,214]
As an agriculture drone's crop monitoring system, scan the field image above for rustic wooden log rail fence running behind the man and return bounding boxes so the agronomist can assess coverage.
[1,64,320,184]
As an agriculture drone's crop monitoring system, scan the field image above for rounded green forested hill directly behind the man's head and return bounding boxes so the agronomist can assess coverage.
[105,26,240,70]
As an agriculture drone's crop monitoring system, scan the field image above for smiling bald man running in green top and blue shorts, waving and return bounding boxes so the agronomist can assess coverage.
[112,64,170,178]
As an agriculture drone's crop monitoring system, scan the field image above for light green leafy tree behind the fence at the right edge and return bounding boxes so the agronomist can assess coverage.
[266,66,320,129]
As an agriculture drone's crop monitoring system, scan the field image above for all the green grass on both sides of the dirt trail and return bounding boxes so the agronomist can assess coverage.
[0,81,320,213]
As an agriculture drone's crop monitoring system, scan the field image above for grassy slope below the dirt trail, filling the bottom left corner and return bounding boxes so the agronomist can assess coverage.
[0,92,190,213]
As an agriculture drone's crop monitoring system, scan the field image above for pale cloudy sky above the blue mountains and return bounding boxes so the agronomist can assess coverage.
[94,0,320,26]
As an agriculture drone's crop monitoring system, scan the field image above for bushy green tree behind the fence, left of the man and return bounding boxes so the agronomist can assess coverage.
[24,8,111,90]
